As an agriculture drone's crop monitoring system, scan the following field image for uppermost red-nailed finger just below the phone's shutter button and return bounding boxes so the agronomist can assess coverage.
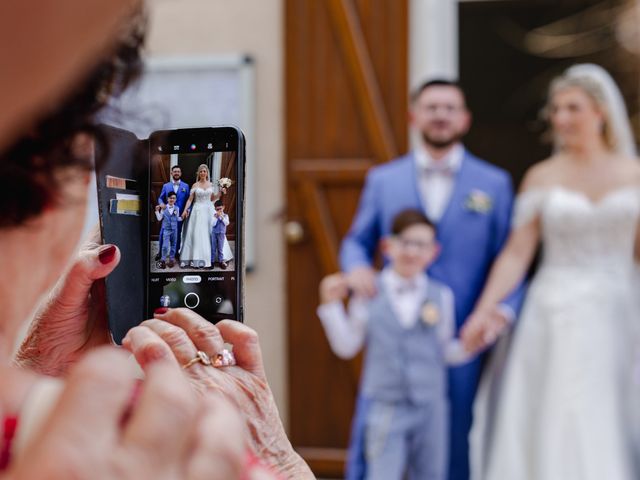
[154,308,225,357]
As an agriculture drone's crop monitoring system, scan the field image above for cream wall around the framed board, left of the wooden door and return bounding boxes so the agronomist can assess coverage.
[147,0,287,418]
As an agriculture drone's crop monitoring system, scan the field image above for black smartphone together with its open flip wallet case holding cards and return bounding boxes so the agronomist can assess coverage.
[96,126,245,344]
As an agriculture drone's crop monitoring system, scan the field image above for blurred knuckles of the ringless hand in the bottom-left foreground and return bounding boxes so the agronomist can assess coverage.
[3,348,245,480]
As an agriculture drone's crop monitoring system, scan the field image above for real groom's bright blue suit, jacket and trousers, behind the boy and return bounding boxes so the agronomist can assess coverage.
[340,152,523,480]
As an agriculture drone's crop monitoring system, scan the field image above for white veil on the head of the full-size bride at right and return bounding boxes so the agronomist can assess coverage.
[563,63,637,157]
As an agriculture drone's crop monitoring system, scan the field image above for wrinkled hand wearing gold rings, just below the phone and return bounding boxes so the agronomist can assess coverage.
[123,308,315,480]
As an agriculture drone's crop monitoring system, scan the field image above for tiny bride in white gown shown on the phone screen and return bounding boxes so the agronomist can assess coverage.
[180,163,233,268]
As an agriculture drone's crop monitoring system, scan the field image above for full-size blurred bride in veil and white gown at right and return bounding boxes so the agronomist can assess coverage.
[462,64,640,480]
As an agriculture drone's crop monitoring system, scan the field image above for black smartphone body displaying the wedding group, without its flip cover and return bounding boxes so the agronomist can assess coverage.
[147,127,244,322]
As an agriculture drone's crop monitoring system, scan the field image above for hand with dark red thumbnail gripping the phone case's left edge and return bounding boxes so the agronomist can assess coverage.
[16,227,120,376]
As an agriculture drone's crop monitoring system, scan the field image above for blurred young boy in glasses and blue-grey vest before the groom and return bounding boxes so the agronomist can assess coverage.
[318,210,468,480]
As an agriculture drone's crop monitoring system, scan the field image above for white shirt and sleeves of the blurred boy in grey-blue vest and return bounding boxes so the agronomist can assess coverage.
[317,267,470,365]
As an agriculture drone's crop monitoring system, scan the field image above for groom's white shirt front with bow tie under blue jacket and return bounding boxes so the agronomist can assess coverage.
[414,143,464,222]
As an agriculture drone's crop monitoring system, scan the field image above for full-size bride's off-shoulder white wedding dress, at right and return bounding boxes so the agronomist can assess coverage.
[470,187,640,480]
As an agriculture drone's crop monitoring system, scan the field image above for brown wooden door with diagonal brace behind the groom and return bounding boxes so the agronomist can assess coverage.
[285,0,408,478]
